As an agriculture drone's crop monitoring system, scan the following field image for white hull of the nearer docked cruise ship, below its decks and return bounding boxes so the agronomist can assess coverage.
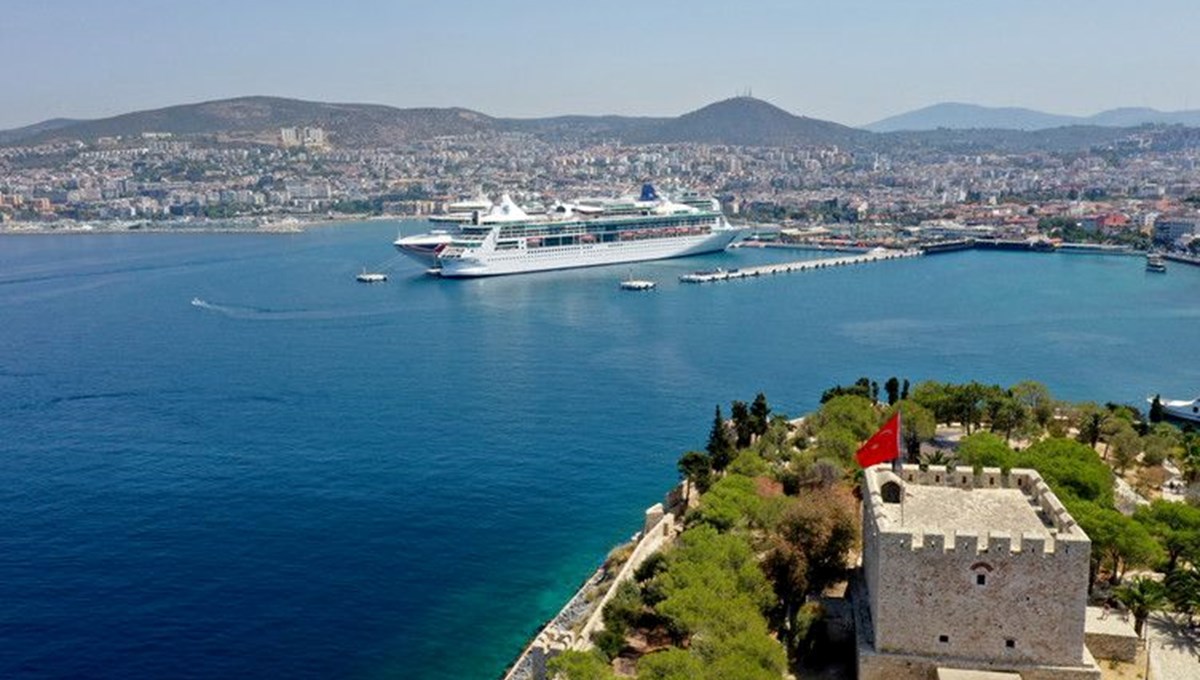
[438,229,740,278]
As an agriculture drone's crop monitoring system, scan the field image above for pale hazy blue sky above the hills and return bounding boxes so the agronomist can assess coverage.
[0,0,1200,128]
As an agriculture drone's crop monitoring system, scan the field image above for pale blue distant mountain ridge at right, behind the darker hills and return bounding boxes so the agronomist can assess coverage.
[864,102,1200,132]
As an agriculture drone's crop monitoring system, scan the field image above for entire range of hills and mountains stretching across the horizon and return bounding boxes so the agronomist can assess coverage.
[0,96,1200,151]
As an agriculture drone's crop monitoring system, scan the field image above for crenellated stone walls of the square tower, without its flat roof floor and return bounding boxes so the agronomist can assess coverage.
[863,467,1091,667]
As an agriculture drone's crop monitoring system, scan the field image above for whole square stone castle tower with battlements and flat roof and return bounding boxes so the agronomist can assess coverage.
[854,465,1100,680]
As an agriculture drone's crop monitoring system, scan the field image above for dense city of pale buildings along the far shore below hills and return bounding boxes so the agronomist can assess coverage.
[7,114,1200,253]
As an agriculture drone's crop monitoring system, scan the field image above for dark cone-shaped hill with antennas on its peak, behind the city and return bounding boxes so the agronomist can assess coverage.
[625,97,870,146]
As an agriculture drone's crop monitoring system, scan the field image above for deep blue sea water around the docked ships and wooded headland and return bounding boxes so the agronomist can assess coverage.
[0,221,1200,679]
